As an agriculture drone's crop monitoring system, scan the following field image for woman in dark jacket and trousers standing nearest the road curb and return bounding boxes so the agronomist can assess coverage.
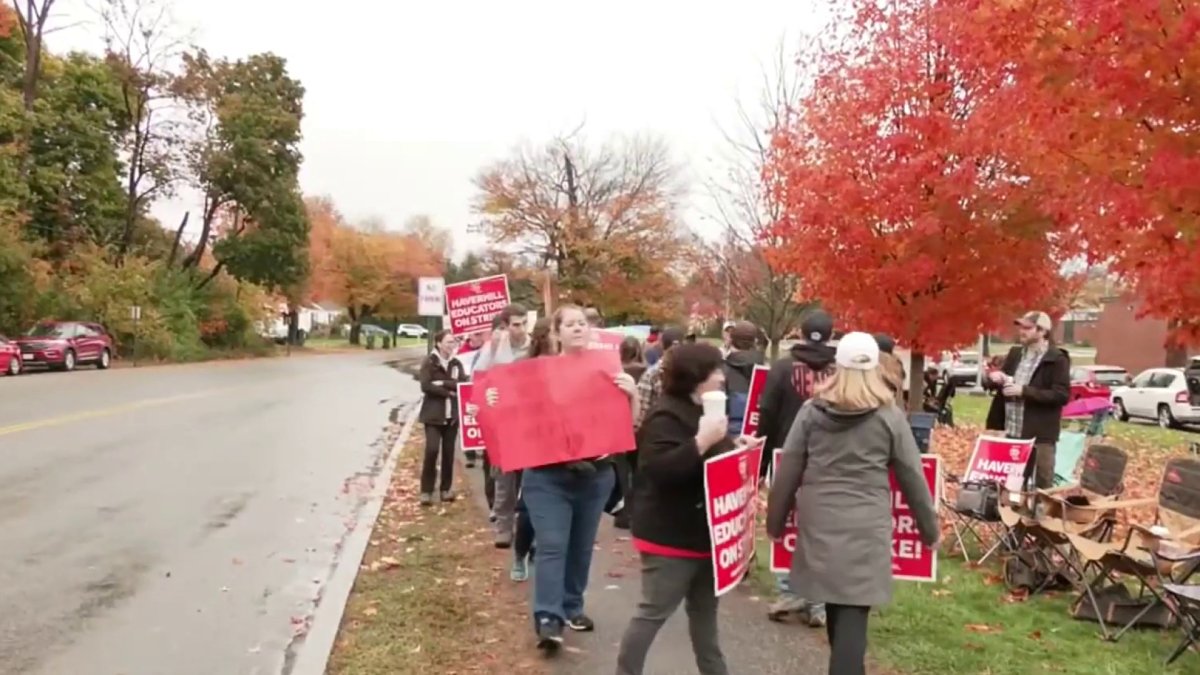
[416,330,467,506]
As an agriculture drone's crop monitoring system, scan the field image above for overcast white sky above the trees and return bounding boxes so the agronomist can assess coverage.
[48,0,823,255]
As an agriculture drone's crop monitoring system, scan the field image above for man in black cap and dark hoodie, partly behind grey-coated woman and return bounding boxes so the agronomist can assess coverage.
[758,310,836,628]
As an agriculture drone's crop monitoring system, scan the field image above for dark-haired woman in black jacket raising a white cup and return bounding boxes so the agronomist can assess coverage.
[617,342,750,675]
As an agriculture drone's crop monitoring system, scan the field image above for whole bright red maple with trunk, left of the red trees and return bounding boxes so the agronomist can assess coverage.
[763,0,1075,402]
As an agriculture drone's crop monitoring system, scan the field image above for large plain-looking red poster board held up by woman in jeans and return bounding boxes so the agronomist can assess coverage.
[472,351,636,471]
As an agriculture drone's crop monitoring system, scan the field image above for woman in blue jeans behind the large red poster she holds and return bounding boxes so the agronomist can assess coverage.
[522,305,637,653]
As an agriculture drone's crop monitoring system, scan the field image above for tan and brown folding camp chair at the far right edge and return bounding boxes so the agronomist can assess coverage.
[1069,458,1200,641]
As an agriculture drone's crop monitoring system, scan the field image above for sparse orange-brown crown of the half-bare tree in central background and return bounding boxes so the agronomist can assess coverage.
[474,138,689,322]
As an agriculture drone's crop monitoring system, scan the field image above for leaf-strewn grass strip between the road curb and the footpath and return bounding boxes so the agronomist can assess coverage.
[326,425,545,675]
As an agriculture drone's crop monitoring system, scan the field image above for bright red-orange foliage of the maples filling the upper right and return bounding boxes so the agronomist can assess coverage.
[764,0,1200,352]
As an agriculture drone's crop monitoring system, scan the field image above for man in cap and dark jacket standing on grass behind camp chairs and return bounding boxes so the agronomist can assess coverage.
[984,312,1070,488]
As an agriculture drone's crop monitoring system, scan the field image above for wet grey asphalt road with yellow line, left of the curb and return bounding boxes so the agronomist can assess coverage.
[0,351,419,675]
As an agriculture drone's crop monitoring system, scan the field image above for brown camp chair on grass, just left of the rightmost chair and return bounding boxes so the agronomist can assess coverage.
[1002,444,1128,595]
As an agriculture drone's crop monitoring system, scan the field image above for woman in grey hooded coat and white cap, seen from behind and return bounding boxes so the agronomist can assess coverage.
[767,333,938,675]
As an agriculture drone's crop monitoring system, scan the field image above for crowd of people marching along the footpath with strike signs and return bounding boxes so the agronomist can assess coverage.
[419,305,938,675]
